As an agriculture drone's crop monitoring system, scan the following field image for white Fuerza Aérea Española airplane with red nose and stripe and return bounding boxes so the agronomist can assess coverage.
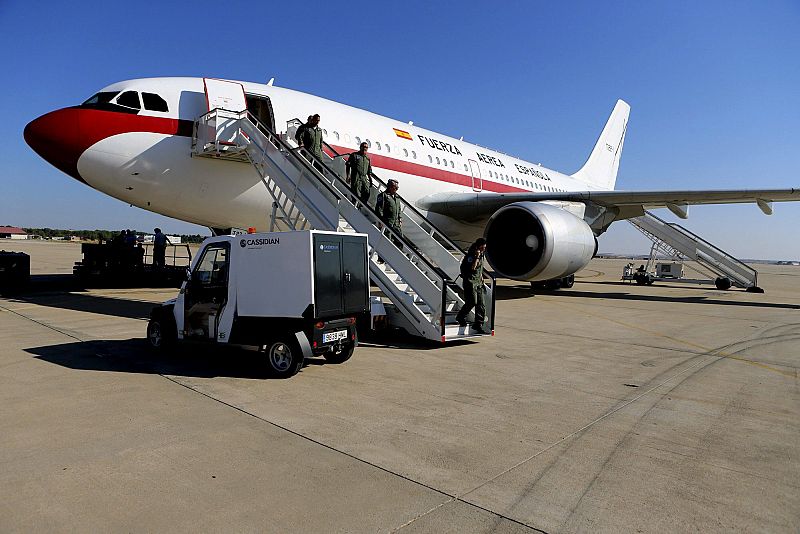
[24,77,800,285]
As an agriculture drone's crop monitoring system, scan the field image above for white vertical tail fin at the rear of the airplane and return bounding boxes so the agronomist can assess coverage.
[572,100,631,190]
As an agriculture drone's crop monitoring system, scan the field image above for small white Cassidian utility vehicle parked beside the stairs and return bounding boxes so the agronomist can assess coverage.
[147,230,369,377]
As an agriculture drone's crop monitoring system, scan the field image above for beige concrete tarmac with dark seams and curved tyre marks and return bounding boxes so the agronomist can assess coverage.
[0,242,800,532]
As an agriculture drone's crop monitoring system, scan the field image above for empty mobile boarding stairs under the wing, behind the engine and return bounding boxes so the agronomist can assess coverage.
[628,211,763,292]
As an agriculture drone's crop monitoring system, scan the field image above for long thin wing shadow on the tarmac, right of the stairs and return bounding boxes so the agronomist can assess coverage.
[496,282,800,310]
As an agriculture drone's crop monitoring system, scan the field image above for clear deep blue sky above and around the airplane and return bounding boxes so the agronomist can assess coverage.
[0,0,800,259]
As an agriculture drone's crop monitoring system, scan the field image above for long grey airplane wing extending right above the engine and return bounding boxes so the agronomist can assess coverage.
[417,189,800,221]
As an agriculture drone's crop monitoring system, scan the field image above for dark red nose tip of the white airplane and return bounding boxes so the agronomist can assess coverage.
[23,108,86,182]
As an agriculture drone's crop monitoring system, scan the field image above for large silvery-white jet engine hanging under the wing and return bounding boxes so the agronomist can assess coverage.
[484,202,597,281]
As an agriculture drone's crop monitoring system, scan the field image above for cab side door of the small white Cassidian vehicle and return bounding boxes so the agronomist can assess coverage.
[184,243,230,339]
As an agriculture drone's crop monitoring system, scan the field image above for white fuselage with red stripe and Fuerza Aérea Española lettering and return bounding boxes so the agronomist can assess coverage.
[67,78,590,241]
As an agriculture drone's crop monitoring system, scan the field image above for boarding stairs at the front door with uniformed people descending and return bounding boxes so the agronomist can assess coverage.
[192,109,495,342]
